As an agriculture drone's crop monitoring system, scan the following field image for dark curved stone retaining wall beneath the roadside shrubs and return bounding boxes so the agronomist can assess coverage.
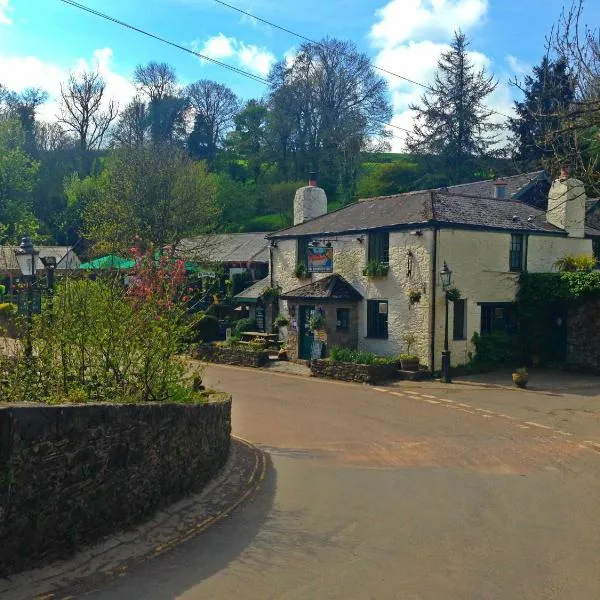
[0,398,231,577]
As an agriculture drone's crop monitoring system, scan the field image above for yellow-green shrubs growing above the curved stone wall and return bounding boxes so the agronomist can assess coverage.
[3,270,204,403]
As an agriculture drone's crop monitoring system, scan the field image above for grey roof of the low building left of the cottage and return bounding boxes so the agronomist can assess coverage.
[177,233,269,264]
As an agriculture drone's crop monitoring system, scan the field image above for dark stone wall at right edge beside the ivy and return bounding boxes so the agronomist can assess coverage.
[567,298,600,372]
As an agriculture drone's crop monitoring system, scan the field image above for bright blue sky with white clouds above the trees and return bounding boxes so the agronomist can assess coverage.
[0,0,600,151]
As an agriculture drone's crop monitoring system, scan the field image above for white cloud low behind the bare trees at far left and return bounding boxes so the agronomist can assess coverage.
[0,49,135,121]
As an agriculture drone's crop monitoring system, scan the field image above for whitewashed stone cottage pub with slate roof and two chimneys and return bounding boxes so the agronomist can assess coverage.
[268,172,600,370]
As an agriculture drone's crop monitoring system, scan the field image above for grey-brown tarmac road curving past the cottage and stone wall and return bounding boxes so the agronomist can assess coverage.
[83,366,600,600]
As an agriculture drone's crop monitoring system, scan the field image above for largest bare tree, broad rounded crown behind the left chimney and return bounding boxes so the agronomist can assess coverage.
[269,39,392,195]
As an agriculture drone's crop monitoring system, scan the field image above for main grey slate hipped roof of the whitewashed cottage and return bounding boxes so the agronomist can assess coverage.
[269,191,564,238]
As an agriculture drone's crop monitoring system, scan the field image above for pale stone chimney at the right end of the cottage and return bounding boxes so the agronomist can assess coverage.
[546,166,587,238]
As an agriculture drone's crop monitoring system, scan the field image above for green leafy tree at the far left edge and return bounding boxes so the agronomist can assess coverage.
[0,118,39,244]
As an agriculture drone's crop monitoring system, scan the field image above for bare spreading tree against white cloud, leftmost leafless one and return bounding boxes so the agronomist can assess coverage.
[58,71,118,171]
